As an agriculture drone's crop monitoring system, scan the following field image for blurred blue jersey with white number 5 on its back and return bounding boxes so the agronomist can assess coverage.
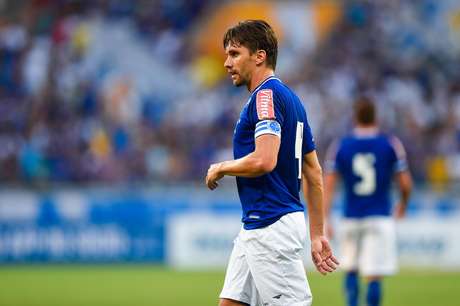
[326,128,407,218]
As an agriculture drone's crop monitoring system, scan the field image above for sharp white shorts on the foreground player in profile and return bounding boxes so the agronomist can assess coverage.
[220,212,312,306]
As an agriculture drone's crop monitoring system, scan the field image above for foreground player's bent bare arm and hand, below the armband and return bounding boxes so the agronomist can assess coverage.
[206,134,281,190]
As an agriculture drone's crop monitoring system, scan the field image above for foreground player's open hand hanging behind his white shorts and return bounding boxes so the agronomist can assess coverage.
[311,236,339,275]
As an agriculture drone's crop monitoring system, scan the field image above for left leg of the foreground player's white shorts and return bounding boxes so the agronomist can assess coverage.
[219,233,257,306]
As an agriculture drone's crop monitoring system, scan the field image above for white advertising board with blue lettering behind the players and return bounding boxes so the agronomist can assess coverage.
[166,212,460,269]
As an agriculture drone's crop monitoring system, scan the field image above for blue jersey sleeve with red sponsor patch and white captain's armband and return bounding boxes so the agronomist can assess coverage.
[248,88,284,138]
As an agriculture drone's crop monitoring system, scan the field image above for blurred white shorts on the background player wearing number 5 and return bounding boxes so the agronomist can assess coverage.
[339,217,397,276]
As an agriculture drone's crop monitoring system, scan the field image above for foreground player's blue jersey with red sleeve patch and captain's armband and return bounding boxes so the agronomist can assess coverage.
[233,77,315,229]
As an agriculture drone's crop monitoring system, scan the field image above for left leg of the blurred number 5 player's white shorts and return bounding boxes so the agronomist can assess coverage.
[339,218,362,271]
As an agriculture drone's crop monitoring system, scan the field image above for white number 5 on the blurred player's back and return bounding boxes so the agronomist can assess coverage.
[353,153,376,196]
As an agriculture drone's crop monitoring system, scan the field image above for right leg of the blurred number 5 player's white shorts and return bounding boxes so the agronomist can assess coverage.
[360,217,397,276]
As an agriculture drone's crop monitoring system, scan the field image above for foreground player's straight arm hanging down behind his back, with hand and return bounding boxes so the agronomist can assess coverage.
[302,150,339,275]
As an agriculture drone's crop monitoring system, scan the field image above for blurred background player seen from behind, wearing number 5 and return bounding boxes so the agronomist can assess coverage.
[325,98,412,306]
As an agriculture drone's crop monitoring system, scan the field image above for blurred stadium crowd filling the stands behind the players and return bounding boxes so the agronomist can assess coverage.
[0,0,460,184]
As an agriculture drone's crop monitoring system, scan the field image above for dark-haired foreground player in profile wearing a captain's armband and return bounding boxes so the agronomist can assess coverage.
[206,20,338,306]
